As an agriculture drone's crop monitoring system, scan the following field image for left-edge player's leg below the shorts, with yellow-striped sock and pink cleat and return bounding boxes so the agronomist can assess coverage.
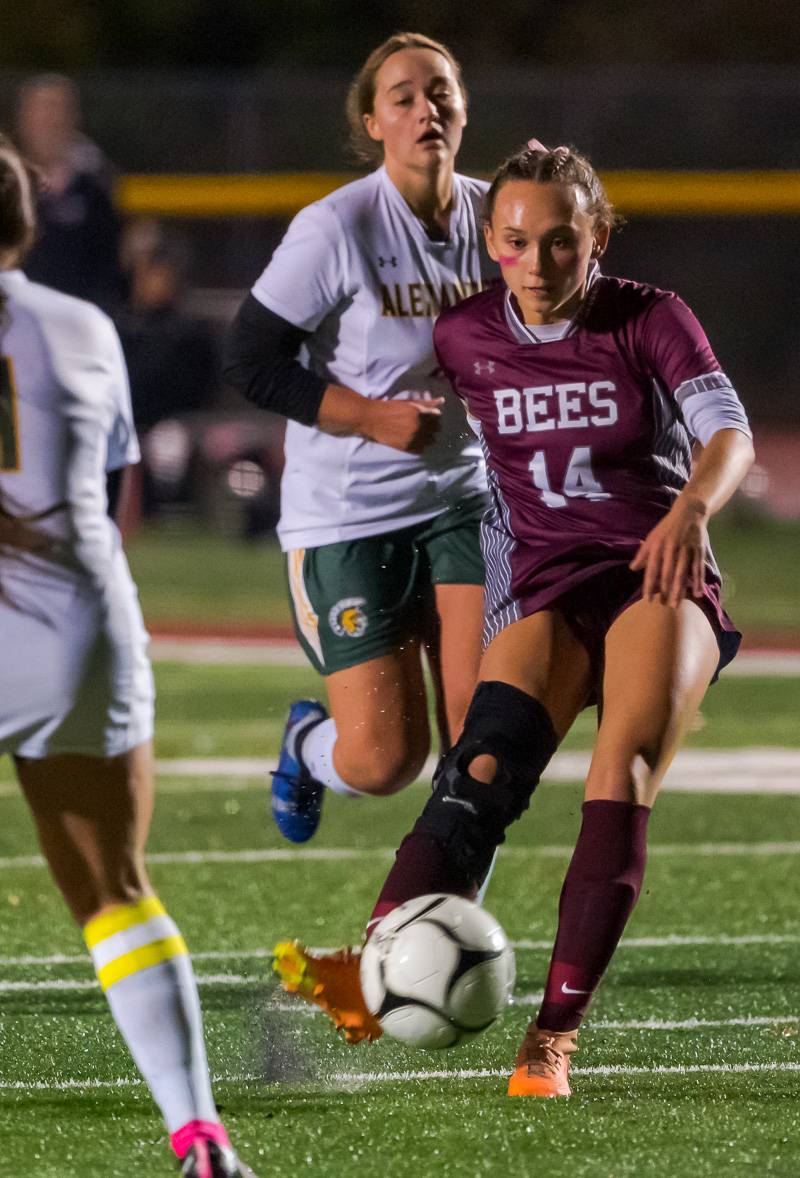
[16,742,251,1178]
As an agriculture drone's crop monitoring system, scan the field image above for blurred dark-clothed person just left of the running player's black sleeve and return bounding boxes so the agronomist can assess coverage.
[114,221,219,515]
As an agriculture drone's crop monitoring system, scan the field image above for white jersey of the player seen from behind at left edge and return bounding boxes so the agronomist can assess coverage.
[0,270,139,587]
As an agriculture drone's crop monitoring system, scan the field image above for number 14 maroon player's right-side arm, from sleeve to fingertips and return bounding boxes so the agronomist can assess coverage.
[630,299,755,607]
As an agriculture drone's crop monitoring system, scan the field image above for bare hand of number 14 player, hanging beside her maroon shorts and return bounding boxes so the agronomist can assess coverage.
[630,498,708,609]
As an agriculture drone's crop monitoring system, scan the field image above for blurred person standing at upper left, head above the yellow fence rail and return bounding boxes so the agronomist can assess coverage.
[16,74,125,311]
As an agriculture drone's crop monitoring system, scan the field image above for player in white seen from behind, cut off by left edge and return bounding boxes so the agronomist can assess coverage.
[0,137,252,1178]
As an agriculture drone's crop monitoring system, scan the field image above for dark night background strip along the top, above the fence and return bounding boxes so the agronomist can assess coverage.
[0,0,800,72]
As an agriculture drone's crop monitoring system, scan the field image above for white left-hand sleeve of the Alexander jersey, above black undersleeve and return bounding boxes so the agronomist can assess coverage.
[252,204,350,331]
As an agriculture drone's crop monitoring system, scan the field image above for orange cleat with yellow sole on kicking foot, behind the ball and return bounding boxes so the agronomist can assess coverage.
[272,941,383,1044]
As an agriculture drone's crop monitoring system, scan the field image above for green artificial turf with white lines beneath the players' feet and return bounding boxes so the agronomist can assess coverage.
[0,650,800,1178]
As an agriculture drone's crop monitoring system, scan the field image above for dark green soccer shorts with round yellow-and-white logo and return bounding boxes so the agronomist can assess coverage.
[286,495,487,675]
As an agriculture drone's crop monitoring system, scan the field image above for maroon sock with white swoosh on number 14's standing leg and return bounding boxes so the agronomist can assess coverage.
[536,801,650,1031]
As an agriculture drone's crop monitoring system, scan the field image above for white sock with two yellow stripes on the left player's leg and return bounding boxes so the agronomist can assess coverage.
[84,895,219,1133]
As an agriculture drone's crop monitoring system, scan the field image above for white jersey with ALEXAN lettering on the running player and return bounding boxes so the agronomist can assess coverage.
[252,167,497,550]
